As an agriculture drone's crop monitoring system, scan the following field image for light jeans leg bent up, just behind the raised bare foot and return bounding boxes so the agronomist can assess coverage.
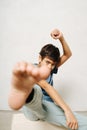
[23,85,46,121]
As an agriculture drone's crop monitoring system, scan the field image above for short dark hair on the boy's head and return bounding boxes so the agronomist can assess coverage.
[39,44,60,63]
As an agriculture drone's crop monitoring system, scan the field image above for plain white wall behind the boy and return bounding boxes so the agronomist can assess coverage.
[0,0,87,111]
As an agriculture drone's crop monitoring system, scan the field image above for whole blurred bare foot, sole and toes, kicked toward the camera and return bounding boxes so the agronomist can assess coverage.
[8,62,50,110]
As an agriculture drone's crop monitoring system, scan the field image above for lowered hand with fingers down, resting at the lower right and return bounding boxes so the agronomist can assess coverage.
[65,111,78,130]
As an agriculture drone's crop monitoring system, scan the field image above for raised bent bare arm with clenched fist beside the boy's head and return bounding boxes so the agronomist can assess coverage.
[51,29,72,67]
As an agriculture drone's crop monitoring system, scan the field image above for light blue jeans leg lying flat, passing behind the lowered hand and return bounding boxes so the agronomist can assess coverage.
[43,101,87,130]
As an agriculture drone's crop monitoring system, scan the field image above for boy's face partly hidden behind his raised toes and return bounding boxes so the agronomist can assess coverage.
[39,56,56,71]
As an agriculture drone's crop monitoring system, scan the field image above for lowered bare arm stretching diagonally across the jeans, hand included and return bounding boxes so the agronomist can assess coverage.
[37,80,78,129]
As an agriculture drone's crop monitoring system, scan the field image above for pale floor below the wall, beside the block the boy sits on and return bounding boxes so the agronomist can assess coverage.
[0,111,87,130]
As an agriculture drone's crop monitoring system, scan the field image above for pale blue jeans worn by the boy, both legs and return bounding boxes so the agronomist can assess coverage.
[23,85,87,130]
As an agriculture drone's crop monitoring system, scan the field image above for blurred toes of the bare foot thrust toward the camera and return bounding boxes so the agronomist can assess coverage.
[13,62,50,81]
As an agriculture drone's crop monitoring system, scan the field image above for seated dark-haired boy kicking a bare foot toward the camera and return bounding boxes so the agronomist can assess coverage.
[8,29,87,130]
